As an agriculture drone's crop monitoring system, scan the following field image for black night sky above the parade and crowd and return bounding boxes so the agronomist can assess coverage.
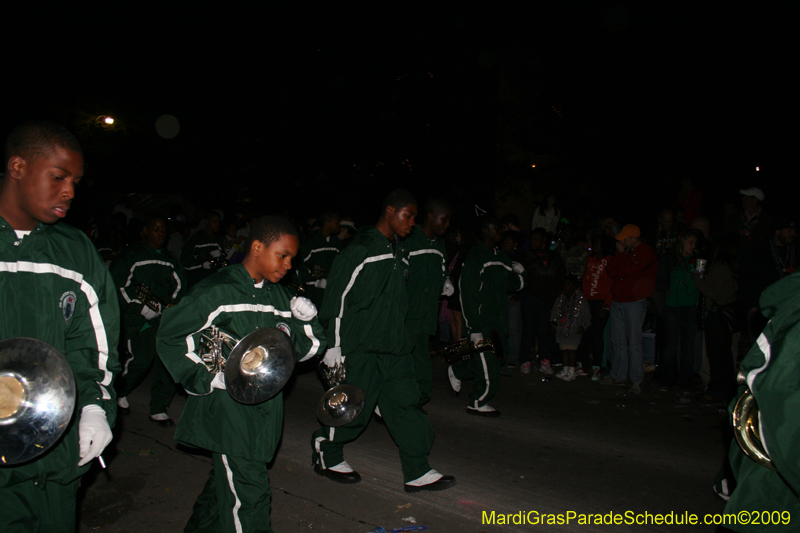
[2,2,798,227]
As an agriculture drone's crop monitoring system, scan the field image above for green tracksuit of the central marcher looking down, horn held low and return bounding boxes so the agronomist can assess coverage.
[312,226,434,483]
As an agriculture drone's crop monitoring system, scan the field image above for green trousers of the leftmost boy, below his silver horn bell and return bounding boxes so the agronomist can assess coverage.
[0,476,81,533]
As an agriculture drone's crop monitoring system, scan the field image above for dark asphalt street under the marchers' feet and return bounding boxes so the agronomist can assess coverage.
[79,361,726,533]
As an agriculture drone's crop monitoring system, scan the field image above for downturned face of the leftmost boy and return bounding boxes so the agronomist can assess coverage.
[6,146,83,231]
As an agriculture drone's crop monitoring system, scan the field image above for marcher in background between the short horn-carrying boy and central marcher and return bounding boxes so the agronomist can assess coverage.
[295,211,342,306]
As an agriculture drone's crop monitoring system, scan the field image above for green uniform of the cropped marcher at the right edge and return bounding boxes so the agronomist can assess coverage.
[725,273,800,532]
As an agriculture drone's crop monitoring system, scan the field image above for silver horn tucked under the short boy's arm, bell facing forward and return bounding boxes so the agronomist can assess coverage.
[200,326,296,405]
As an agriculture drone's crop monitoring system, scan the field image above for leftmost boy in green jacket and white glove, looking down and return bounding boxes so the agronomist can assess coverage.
[0,121,119,533]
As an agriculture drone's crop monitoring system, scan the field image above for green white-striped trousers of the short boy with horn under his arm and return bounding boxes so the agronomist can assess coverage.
[184,453,272,533]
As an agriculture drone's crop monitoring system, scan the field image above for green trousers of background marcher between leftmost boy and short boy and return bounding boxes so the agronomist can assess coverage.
[116,327,177,415]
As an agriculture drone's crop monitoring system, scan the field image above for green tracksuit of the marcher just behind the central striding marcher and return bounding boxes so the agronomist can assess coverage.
[403,226,447,405]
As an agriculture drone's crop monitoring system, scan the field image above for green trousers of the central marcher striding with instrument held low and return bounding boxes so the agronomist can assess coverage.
[311,354,433,483]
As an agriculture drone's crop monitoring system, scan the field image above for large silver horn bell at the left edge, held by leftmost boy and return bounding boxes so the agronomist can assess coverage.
[0,337,76,465]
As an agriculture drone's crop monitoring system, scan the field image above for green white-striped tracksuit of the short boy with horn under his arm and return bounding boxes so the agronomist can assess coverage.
[158,264,325,532]
